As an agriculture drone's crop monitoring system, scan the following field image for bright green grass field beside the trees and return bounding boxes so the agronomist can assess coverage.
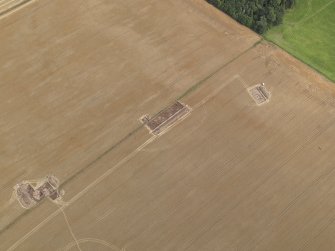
[265,0,335,82]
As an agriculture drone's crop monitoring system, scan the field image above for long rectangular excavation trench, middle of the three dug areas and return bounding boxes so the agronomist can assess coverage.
[140,101,191,135]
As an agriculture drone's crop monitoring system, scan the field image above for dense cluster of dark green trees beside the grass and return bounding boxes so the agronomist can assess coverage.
[207,0,295,34]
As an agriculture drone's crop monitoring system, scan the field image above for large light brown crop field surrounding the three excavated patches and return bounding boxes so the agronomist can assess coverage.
[0,0,335,251]
